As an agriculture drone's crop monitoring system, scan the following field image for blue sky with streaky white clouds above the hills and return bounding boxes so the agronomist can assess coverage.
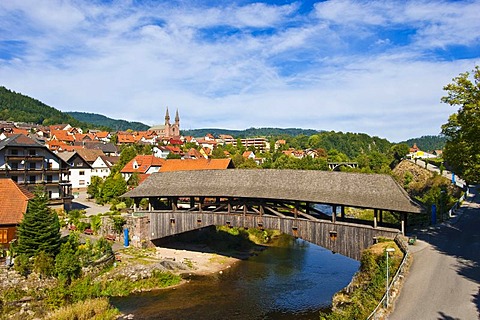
[0,0,480,141]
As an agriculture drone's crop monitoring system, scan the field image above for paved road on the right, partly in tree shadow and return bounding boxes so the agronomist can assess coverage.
[388,187,480,320]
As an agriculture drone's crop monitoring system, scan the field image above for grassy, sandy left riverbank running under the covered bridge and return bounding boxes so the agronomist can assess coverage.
[0,227,276,320]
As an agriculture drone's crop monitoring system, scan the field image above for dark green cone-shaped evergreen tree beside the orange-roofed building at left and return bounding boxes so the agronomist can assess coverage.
[16,189,60,257]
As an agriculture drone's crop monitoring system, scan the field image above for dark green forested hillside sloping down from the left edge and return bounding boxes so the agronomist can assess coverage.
[0,86,87,128]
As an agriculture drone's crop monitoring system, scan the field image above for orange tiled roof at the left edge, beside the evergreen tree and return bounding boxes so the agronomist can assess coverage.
[0,179,33,225]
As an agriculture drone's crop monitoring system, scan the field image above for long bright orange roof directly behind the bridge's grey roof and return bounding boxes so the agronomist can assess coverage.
[160,158,233,172]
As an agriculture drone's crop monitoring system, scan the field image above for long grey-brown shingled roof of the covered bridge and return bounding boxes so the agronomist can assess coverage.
[123,169,423,213]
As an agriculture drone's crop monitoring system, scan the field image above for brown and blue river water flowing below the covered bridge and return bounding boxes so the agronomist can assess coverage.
[112,239,359,319]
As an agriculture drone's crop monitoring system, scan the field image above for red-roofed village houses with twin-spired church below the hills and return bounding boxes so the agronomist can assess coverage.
[0,109,440,248]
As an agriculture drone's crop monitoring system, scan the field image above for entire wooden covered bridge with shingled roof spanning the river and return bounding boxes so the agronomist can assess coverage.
[123,169,422,260]
